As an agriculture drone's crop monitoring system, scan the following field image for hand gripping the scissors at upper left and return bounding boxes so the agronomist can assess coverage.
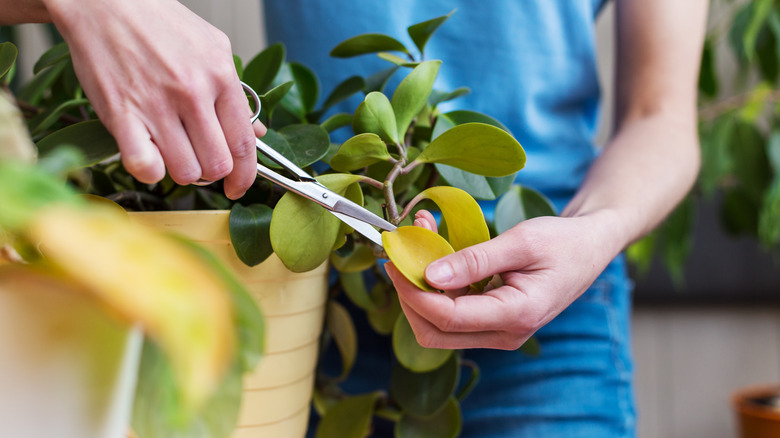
[45,0,265,199]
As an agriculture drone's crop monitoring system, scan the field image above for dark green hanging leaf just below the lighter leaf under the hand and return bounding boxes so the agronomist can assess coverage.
[390,354,460,417]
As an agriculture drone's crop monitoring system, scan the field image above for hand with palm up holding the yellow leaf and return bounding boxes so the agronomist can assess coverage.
[385,212,621,350]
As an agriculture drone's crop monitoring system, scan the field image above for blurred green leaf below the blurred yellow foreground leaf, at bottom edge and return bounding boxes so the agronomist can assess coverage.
[132,341,242,438]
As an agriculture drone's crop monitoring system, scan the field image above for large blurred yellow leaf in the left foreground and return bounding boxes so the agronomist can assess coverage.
[30,206,235,406]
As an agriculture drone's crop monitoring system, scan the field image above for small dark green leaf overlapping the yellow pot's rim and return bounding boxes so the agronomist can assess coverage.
[229,204,274,266]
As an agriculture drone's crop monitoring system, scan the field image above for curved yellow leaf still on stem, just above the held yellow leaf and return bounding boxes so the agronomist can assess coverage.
[411,186,490,251]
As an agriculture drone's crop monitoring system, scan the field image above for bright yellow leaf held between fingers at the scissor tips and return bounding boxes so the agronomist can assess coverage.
[382,226,455,291]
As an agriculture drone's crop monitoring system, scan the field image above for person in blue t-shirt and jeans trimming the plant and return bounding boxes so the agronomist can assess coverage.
[0,0,707,438]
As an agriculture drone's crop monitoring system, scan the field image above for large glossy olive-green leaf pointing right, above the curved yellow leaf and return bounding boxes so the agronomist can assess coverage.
[415,123,525,176]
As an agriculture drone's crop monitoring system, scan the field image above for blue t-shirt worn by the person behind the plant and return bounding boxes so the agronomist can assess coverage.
[265,0,605,205]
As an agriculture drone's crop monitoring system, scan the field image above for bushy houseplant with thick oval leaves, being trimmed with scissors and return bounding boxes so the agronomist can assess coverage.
[1,9,552,436]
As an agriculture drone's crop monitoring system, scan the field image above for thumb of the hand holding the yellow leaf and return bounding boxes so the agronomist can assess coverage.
[425,236,521,290]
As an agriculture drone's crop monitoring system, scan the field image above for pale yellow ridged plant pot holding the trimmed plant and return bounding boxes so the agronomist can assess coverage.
[131,211,328,438]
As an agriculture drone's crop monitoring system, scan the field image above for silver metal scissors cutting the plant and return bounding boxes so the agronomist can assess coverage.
[213,82,396,246]
